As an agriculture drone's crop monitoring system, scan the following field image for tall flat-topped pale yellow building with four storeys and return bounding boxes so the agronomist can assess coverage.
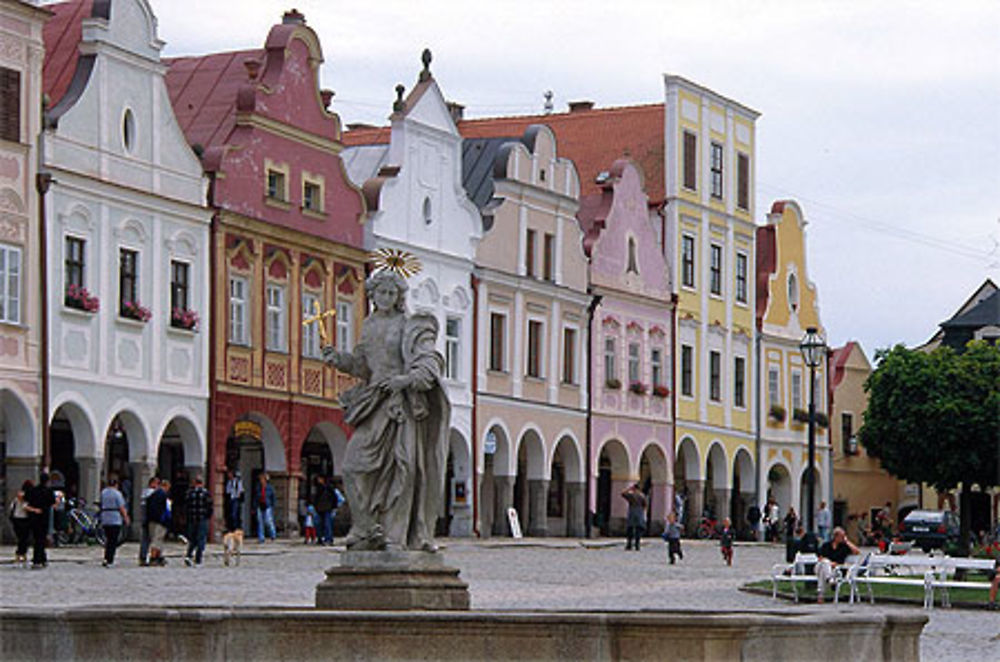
[664,76,759,530]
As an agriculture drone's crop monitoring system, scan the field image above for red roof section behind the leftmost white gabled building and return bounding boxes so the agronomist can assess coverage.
[42,0,94,108]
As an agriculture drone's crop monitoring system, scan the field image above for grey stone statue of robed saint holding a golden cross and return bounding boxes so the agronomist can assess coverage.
[323,269,451,552]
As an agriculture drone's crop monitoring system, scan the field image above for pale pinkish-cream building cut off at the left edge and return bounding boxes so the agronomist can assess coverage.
[0,0,48,511]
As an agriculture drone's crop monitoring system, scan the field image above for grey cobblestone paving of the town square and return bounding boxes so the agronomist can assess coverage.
[0,538,1000,662]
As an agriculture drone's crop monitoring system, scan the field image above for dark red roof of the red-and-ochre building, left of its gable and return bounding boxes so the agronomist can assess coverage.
[164,48,264,149]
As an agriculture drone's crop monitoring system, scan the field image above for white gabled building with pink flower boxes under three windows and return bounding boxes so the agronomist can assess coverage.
[42,0,210,524]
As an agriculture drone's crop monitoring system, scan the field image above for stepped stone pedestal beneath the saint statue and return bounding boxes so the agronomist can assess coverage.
[316,551,469,611]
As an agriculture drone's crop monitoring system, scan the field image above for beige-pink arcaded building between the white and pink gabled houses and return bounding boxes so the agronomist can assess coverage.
[476,126,589,536]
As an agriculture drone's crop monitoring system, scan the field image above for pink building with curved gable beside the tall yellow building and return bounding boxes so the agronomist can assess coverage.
[578,159,674,535]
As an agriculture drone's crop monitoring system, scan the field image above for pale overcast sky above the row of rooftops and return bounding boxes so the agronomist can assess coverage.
[145,0,1000,356]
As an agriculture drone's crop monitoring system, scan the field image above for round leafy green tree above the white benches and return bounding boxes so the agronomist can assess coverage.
[858,341,1000,553]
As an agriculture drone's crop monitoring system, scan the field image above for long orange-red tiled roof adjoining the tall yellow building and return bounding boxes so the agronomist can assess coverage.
[458,104,666,204]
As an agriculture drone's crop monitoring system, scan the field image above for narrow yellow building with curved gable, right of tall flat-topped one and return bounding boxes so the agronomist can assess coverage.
[757,201,831,518]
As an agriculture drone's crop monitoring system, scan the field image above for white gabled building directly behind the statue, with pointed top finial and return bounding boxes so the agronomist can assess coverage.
[342,53,482,536]
